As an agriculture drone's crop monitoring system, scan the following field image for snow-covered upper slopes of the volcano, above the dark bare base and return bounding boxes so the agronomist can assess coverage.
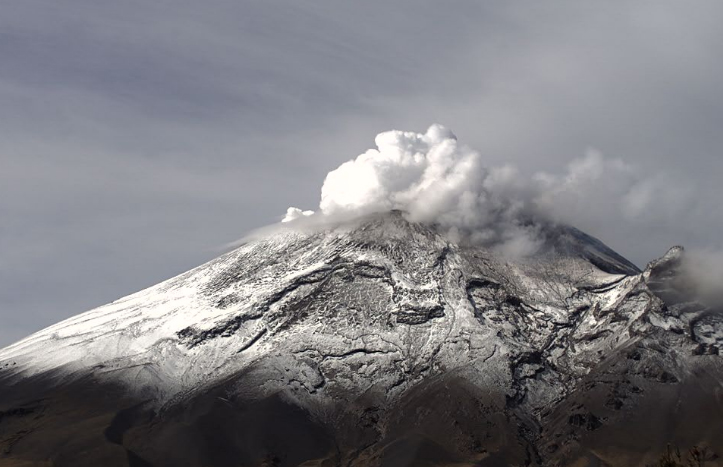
[0,212,723,409]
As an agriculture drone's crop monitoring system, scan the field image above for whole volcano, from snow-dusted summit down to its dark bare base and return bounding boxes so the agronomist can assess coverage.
[0,213,723,466]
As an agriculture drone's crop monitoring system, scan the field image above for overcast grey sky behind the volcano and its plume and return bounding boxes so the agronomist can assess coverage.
[0,0,723,346]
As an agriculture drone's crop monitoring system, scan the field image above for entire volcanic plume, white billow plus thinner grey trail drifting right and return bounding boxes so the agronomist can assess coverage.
[284,124,692,257]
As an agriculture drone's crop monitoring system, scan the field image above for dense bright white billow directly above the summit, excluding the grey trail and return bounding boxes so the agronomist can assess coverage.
[319,125,539,255]
